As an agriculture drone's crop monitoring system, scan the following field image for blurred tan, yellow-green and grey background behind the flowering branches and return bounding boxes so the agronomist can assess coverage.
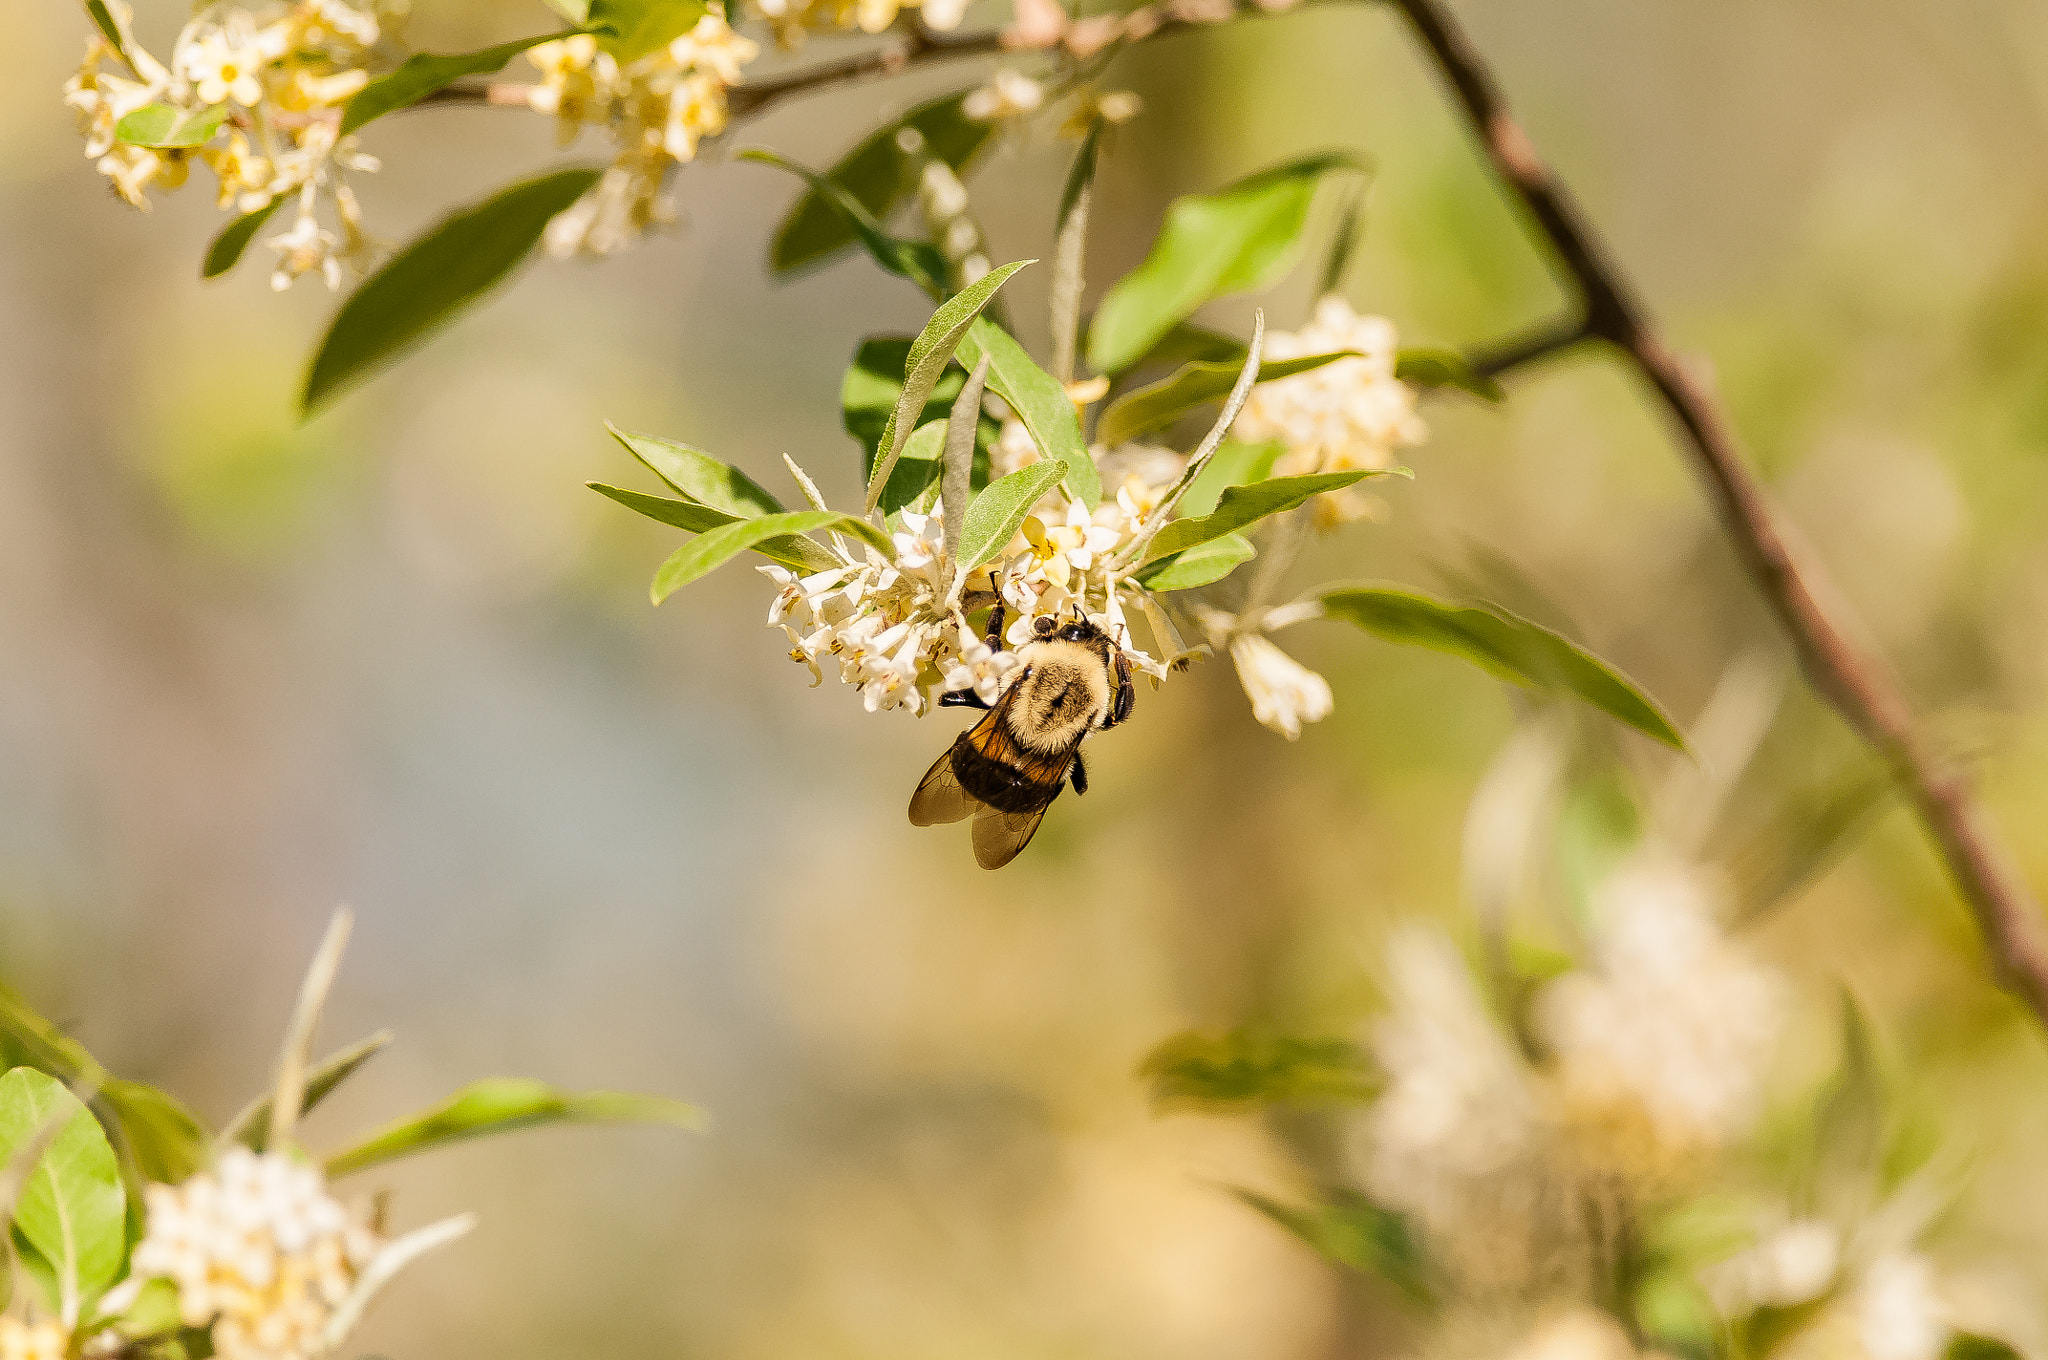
[0,0,2048,1360]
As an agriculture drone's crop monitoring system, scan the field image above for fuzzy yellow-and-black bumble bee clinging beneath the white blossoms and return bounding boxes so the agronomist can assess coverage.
[909,604,1137,868]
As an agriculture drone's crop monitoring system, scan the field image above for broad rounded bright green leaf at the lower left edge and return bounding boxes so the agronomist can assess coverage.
[0,1067,127,1305]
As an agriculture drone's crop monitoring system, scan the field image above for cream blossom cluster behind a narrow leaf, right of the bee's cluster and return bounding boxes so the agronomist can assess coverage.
[1233,295,1430,522]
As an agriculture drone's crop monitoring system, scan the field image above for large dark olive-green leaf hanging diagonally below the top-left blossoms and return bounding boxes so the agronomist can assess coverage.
[299,168,598,414]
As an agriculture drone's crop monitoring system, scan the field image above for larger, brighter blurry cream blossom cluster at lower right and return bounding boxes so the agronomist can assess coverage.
[1538,858,1786,1170]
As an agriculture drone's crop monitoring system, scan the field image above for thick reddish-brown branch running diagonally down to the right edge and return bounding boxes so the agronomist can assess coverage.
[1395,0,2048,1024]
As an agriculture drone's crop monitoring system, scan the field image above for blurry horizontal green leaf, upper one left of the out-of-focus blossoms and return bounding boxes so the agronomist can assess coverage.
[1139,1028,1378,1108]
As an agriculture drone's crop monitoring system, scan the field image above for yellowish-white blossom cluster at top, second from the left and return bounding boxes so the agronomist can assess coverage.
[526,10,760,258]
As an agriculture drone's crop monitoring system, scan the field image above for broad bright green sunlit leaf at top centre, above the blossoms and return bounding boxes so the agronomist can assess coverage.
[1087,152,1364,373]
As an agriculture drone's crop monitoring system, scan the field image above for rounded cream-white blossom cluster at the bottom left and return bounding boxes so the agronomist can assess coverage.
[131,1147,381,1360]
